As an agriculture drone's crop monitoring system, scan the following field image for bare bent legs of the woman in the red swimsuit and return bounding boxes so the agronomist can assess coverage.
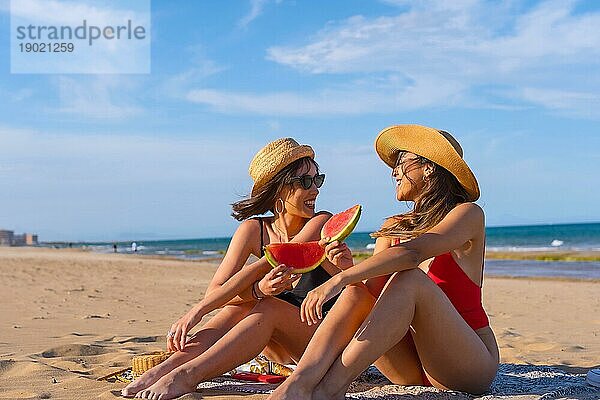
[312,269,498,400]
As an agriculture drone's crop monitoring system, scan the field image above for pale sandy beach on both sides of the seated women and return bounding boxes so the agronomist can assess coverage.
[0,248,600,399]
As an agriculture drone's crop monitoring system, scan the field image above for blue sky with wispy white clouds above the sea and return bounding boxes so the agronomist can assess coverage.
[0,0,600,240]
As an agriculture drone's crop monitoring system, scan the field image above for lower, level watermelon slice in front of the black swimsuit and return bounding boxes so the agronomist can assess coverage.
[265,242,325,274]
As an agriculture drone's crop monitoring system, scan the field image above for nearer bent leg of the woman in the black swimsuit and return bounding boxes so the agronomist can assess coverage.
[136,297,318,400]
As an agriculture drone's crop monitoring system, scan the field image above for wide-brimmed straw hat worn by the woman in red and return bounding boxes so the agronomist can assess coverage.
[375,125,479,201]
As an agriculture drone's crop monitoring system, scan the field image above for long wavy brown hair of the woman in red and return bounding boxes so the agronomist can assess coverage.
[371,152,469,240]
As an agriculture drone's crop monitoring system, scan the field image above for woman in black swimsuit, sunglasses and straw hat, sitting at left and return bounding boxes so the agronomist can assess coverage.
[122,138,340,399]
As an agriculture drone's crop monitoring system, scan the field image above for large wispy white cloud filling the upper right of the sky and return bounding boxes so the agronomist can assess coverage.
[267,0,600,118]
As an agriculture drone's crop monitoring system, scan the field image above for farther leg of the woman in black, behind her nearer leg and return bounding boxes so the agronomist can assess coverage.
[121,303,289,397]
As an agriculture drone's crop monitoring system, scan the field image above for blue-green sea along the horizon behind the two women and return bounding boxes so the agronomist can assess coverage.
[54,223,600,279]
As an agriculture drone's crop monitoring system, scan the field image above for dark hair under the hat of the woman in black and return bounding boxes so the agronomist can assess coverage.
[231,157,319,221]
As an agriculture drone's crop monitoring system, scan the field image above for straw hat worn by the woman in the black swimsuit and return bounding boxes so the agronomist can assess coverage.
[248,138,315,196]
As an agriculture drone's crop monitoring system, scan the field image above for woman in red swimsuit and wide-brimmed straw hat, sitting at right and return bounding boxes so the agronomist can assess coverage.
[269,125,499,400]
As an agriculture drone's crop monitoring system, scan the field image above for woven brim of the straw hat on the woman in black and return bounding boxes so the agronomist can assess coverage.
[250,144,315,196]
